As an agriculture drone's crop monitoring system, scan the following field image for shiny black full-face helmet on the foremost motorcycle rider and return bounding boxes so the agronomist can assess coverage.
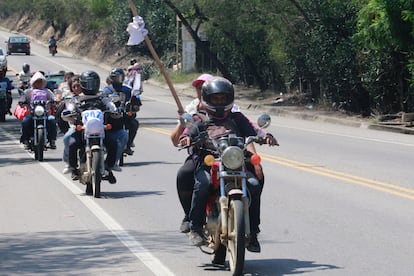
[201,77,234,119]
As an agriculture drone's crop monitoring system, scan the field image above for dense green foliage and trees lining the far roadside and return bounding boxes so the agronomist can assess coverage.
[0,0,414,115]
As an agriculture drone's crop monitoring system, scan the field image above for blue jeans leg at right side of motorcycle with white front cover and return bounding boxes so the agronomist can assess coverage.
[105,129,128,168]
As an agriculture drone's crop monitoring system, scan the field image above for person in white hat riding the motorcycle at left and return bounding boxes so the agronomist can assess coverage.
[19,72,57,149]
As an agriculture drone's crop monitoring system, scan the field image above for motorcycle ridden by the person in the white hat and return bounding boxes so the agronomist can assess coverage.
[29,101,53,161]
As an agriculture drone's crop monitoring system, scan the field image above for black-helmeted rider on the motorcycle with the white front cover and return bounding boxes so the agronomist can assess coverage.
[64,71,118,184]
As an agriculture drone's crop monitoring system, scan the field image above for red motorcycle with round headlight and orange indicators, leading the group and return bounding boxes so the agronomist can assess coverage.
[180,114,271,275]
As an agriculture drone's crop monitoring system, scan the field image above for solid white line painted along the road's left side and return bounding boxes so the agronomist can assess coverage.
[0,127,174,276]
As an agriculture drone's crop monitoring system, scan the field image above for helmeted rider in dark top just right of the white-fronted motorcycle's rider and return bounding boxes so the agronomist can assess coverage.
[103,67,142,155]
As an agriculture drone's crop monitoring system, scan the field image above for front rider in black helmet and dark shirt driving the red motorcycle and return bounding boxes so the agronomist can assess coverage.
[180,77,278,252]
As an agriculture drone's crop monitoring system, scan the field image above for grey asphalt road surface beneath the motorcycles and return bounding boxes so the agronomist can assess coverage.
[0,26,414,276]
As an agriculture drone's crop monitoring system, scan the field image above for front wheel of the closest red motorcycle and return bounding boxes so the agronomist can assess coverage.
[228,199,246,275]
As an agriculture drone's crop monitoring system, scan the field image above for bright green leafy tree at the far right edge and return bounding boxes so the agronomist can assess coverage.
[354,0,414,113]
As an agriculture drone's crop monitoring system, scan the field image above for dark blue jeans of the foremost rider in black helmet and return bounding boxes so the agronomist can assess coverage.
[190,165,262,233]
